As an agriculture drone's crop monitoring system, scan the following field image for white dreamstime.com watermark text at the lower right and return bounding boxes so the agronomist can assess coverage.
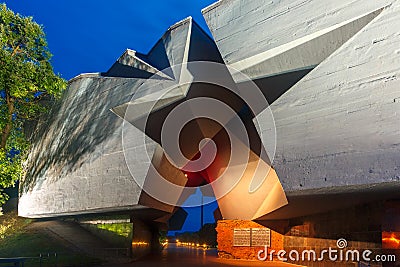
[257,238,396,263]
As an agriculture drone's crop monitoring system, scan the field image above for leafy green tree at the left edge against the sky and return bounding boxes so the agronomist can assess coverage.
[0,4,66,206]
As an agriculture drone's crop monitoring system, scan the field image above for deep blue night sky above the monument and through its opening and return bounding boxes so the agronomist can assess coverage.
[0,0,217,231]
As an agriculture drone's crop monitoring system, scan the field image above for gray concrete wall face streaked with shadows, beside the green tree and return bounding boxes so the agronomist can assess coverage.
[19,77,146,217]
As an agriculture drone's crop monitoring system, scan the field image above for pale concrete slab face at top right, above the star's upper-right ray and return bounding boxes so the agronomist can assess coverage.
[203,0,393,64]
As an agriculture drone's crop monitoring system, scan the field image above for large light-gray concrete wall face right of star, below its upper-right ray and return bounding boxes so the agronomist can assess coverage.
[271,1,400,191]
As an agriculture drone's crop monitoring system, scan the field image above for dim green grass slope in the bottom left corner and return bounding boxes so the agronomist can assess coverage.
[0,213,101,267]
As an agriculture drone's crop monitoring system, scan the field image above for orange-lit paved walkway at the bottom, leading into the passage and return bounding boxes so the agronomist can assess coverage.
[98,244,304,267]
